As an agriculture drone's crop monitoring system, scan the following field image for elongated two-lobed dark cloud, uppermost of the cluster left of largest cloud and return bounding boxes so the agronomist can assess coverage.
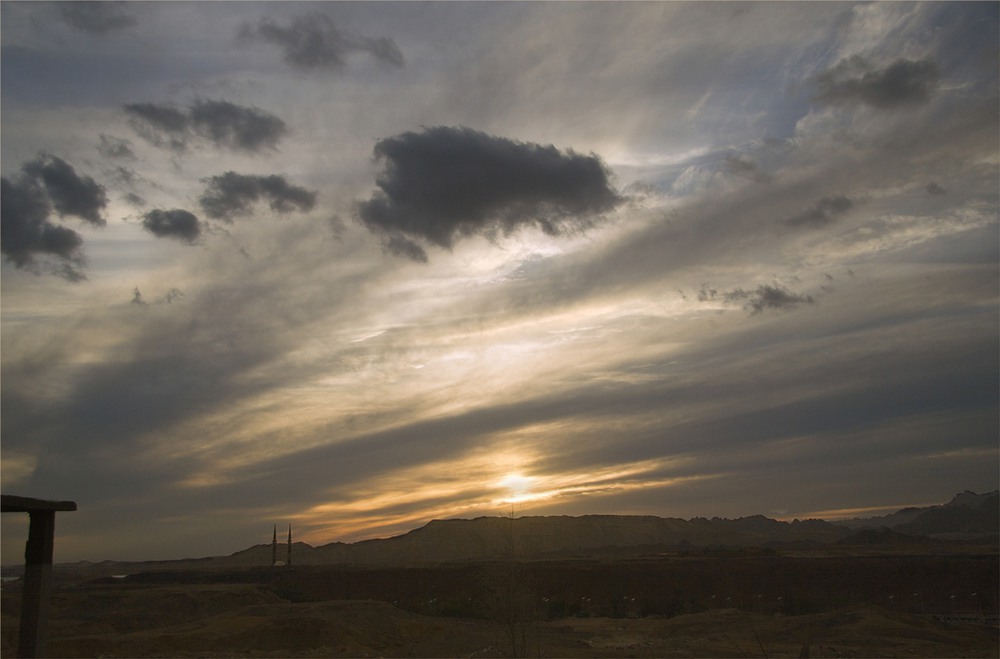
[122,100,288,153]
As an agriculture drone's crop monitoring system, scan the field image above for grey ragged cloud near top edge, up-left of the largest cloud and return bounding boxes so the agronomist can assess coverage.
[239,13,403,71]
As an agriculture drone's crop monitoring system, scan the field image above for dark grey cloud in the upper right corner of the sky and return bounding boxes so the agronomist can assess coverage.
[814,56,939,110]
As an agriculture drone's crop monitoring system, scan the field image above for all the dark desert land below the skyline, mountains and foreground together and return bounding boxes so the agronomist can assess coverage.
[0,492,1000,657]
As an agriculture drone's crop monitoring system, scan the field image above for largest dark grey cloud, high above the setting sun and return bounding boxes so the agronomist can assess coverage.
[358,126,622,260]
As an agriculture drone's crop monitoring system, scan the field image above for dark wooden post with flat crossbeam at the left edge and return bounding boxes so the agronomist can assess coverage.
[0,494,76,657]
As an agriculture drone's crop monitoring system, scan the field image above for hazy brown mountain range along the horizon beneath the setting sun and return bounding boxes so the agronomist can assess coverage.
[62,491,1000,572]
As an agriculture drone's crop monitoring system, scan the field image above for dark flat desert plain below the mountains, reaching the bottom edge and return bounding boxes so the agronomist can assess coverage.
[0,554,1000,657]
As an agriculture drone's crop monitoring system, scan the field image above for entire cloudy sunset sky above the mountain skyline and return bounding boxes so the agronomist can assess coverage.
[0,2,1000,564]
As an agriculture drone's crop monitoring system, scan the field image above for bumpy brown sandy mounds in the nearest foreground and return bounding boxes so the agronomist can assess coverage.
[0,584,1000,657]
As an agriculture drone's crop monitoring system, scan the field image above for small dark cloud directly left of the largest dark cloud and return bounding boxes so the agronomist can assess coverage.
[199,172,316,220]
